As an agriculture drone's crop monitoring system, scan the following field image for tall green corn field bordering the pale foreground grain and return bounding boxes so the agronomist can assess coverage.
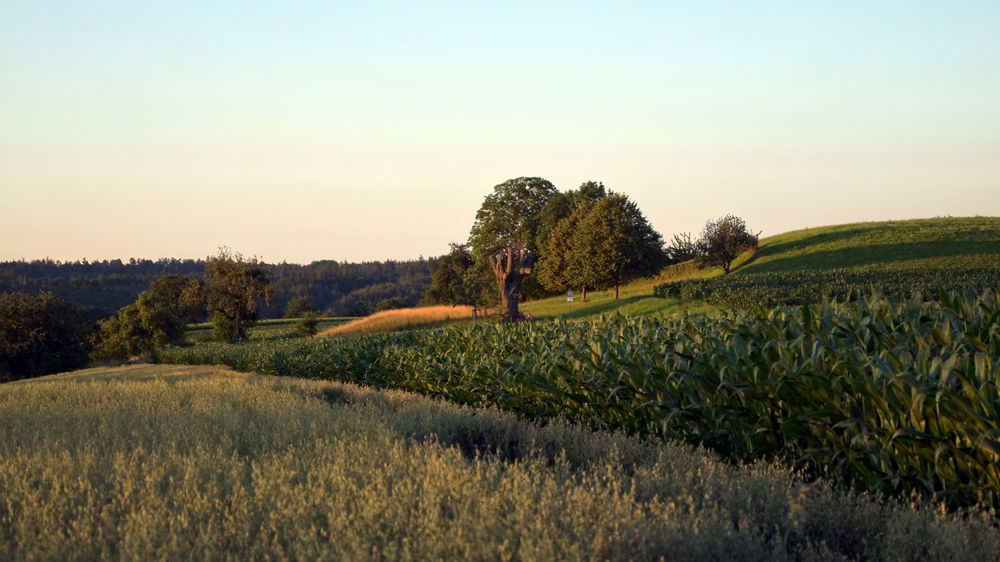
[158,290,1000,508]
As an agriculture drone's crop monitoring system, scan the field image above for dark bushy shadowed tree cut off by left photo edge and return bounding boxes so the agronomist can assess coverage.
[0,293,93,382]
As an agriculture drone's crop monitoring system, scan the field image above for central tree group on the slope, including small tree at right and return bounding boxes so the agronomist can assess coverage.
[424,177,757,320]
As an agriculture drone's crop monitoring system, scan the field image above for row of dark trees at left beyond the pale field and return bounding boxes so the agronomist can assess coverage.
[0,248,282,382]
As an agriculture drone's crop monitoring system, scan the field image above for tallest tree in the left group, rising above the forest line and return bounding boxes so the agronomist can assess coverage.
[205,248,274,340]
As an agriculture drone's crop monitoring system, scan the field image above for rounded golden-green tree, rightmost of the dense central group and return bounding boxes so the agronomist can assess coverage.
[570,193,667,300]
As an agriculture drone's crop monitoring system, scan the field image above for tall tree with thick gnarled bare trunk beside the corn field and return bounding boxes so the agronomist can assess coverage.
[469,177,558,320]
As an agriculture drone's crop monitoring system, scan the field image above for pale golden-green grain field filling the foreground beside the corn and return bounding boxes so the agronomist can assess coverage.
[0,366,1000,560]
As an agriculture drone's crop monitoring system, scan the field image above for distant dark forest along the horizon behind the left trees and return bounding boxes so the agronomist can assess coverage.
[0,259,436,320]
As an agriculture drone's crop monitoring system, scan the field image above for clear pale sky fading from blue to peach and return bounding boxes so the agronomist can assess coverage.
[0,0,1000,263]
